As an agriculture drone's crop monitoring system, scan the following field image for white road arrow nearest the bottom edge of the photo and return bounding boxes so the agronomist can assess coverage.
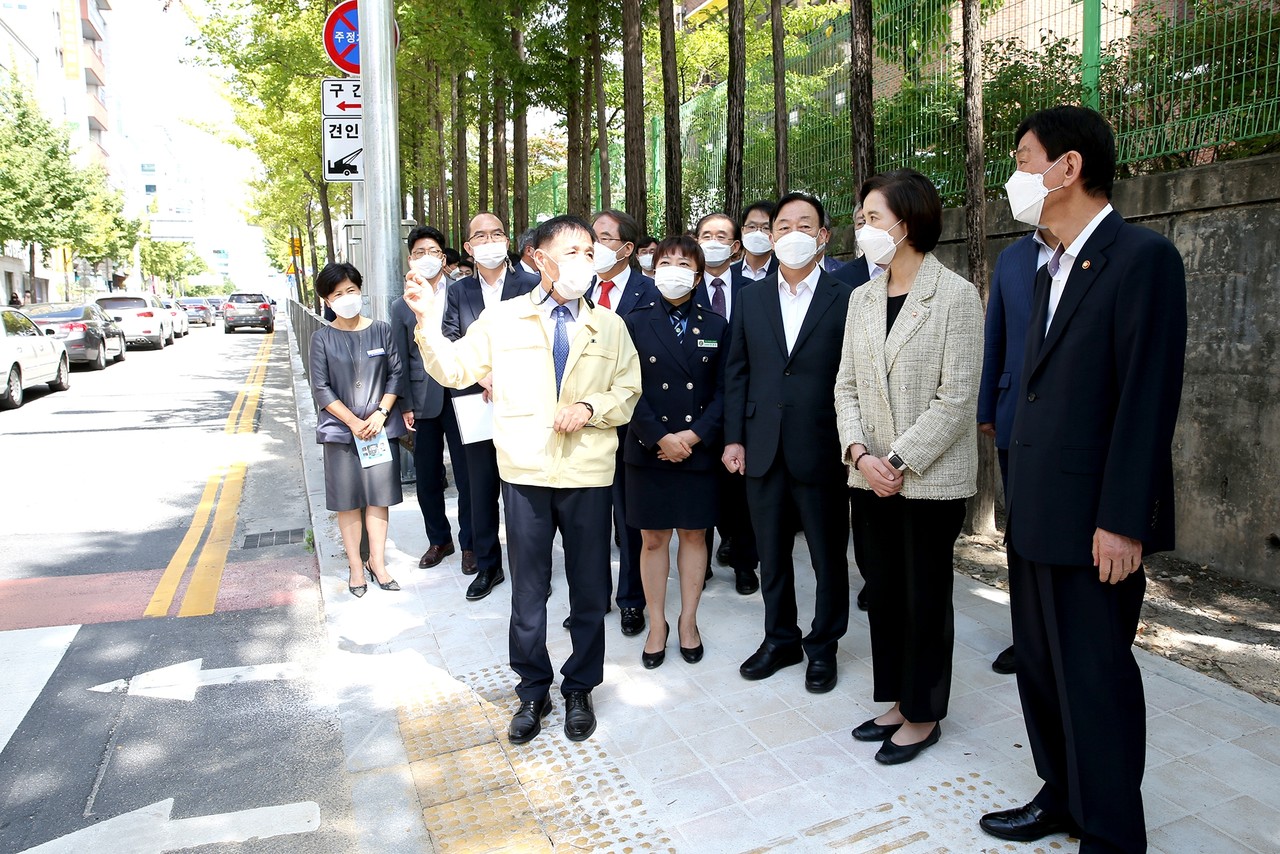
[26,798,320,854]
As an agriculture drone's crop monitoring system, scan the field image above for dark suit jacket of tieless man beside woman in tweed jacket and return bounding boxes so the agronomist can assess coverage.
[724,273,854,484]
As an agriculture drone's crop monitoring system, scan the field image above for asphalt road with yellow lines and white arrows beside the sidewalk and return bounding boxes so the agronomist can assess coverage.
[0,316,355,851]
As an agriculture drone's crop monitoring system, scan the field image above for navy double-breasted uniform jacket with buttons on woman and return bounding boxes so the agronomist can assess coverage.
[622,300,728,470]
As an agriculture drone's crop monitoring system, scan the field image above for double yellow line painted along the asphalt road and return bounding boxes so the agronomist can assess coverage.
[143,335,275,617]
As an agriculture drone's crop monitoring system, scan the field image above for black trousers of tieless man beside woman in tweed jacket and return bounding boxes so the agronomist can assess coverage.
[735,453,849,661]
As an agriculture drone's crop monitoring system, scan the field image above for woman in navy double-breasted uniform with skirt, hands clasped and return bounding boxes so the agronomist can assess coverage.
[622,236,728,670]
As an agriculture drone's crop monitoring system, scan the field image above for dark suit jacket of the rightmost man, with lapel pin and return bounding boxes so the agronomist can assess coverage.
[1009,213,1187,566]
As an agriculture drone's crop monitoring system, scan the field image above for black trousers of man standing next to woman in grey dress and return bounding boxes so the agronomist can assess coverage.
[413,397,472,551]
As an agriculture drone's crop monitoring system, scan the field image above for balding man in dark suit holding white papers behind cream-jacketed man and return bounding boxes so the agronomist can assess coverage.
[440,214,541,602]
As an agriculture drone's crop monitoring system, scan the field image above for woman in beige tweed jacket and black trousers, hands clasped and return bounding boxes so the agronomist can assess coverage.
[836,169,983,764]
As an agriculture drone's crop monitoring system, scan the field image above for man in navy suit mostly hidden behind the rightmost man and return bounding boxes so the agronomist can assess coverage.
[978,229,1057,675]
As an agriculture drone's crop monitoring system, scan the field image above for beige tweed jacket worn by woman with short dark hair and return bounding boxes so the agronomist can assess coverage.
[836,252,983,499]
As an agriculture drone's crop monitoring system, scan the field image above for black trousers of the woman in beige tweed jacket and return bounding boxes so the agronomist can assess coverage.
[852,489,965,723]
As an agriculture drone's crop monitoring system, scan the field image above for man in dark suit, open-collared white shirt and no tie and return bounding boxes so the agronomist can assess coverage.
[723,193,852,693]
